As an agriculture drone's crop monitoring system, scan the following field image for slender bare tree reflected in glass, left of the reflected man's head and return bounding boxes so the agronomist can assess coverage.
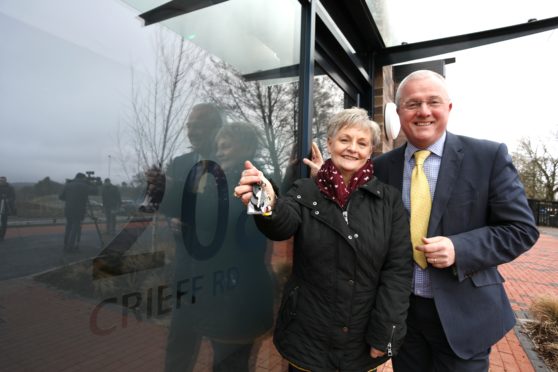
[123,30,207,174]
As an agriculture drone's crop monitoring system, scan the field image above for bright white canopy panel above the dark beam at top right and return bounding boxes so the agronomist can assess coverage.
[366,0,558,46]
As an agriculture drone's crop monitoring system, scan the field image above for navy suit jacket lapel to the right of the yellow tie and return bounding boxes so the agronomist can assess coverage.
[428,132,464,236]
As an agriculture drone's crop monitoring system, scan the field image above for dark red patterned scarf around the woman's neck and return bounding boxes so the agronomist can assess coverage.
[316,159,374,208]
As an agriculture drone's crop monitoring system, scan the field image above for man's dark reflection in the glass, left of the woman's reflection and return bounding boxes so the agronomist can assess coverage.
[146,103,234,371]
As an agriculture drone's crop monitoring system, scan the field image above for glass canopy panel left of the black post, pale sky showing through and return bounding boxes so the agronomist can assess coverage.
[124,0,300,74]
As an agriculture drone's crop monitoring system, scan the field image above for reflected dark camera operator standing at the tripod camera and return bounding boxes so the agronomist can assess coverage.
[59,173,92,253]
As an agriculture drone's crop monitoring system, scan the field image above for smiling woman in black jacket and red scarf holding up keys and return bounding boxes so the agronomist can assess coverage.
[235,108,412,371]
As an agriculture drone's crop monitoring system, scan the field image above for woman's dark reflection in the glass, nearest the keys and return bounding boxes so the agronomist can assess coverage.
[166,123,273,372]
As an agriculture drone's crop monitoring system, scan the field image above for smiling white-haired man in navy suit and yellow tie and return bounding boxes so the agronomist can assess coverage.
[374,71,538,372]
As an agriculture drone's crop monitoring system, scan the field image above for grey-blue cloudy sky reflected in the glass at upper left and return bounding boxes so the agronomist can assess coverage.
[0,0,162,182]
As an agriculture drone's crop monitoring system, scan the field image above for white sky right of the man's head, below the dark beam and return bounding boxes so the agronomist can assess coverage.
[446,30,558,150]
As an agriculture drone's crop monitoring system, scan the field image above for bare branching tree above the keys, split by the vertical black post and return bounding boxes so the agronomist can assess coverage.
[204,61,343,180]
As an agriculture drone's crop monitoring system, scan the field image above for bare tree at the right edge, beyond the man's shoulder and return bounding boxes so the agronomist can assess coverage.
[513,134,558,200]
